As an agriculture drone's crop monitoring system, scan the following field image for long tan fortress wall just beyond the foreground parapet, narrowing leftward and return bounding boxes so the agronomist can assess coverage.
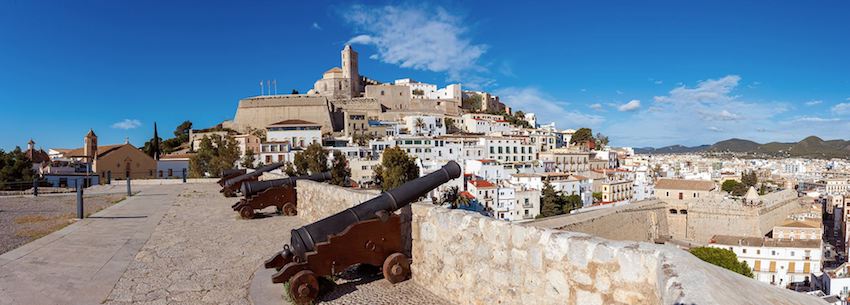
[532,201,669,242]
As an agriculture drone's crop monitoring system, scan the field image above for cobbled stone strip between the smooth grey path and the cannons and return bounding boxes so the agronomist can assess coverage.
[106,184,301,304]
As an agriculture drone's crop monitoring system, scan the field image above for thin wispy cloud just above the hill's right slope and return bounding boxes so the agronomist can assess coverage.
[494,87,605,129]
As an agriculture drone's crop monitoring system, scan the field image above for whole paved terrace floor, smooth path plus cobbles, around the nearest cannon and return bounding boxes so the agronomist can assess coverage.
[0,184,446,305]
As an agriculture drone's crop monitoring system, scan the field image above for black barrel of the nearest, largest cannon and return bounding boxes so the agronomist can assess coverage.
[290,161,461,259]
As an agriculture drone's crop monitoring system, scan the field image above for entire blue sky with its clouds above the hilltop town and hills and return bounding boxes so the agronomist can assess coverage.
[0,0,850,150]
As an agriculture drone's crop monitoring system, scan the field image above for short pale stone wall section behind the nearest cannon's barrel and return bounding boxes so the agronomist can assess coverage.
[297,180,381,223]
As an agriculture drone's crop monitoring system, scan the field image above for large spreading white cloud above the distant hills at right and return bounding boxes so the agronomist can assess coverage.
[602,75,788,147]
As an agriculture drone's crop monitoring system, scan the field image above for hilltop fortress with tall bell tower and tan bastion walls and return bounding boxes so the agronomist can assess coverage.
[223,45,462,133]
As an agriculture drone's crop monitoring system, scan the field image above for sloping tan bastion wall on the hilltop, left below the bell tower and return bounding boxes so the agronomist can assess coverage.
[233,95,333,132]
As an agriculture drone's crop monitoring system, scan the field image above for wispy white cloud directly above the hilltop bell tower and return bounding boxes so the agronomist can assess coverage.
[343,5,487,83]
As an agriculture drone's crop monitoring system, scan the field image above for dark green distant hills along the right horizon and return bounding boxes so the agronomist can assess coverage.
[635,136,850,159]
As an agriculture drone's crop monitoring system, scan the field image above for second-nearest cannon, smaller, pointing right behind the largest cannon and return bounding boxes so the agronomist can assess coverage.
[232,172,331,219]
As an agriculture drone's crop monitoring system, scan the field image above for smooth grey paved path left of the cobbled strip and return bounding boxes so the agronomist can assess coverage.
[0,186,184,305]
